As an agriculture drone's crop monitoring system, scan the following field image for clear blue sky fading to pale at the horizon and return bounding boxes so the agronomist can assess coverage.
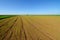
[0,0,60,14]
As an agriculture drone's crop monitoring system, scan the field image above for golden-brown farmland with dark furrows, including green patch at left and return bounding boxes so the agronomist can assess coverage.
[0,15,60,40]
